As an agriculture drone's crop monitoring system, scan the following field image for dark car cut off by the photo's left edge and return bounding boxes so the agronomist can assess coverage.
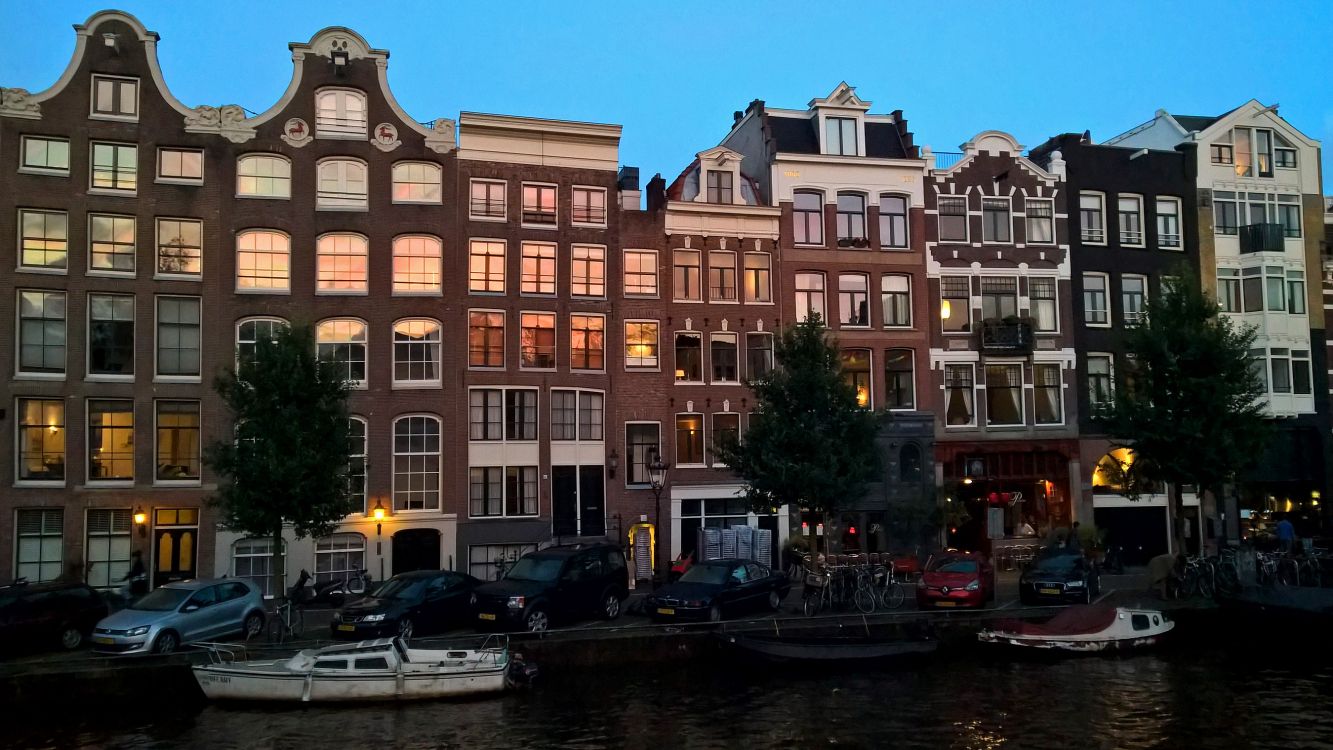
[0,582,109,650]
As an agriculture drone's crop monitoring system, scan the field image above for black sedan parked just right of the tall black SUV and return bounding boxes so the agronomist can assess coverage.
[648,558,792,622]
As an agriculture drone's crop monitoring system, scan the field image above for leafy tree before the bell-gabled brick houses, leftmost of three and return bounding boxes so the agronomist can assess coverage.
[204,326,360,604]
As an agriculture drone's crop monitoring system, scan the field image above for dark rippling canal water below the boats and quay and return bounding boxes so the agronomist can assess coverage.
[12,635,1333,750]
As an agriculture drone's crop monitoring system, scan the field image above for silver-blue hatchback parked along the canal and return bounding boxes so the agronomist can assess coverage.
[92,578,264,654]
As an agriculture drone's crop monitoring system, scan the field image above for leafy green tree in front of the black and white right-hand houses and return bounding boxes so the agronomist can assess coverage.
[1104,268,1269,550]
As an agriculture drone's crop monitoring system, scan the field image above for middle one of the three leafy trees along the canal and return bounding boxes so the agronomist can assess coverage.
[716,316,881,548]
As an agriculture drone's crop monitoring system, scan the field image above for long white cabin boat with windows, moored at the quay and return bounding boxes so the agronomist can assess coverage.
[193,637,533,703]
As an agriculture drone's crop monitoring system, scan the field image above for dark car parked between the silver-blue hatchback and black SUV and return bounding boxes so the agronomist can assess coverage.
[329,570,481,639]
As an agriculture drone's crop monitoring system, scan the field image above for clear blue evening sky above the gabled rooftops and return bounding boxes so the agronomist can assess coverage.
[0,0,1333,194]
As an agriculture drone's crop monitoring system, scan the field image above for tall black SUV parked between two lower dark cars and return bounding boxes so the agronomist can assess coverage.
[476,542,629,633]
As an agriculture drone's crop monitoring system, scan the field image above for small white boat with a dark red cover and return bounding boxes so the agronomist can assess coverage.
[977,605,1176,654]
